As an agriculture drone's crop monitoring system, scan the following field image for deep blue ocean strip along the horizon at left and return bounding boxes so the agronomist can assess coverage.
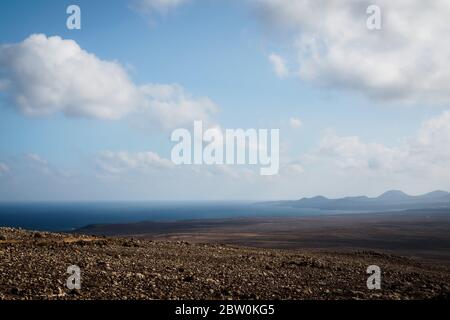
[0,202,329,231]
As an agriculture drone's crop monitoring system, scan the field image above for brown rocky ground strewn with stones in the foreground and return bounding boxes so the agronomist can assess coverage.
[0,228,450,299]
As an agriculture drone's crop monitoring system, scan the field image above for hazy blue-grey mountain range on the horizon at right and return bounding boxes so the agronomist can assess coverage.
[264,190,450,211]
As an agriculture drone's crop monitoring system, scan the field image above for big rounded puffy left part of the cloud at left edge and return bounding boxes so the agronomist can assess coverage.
[0,34,138,119]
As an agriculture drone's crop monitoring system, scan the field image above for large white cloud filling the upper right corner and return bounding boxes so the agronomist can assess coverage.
[252,0,450,103]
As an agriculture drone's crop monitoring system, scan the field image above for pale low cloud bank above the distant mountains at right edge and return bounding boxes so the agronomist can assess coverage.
[306,111,450,178]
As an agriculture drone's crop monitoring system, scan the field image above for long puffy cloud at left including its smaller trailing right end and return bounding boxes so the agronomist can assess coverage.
[0,34,217,128]
